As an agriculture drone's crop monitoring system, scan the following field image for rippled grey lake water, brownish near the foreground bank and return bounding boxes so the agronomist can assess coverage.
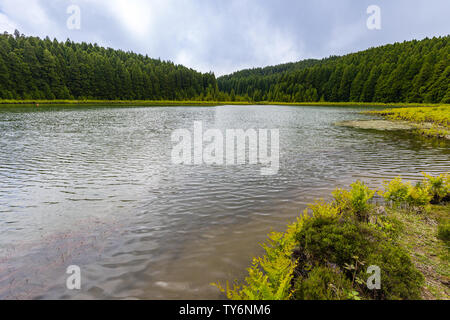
[0,106,450,299]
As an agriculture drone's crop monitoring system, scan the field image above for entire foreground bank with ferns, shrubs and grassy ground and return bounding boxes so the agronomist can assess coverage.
[214,174,450,300]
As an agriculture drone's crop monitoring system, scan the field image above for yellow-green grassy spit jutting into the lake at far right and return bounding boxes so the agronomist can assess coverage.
[368,105,450,139]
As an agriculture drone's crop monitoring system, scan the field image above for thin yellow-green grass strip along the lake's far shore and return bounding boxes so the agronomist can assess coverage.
[0,100,450,108]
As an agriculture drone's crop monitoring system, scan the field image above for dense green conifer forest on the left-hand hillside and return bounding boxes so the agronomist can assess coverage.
[0,31,217,100]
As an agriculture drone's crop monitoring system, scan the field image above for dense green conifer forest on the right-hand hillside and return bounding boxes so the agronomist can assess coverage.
[217,36,450,103]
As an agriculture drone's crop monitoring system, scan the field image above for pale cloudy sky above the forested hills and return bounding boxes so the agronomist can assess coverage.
[0,0,450,75]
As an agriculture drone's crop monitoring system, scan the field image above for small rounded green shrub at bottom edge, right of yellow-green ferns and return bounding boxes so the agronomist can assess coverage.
[294,266,353,300]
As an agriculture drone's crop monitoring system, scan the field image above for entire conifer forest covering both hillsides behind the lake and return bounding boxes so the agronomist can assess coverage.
[0,30,450,103]
